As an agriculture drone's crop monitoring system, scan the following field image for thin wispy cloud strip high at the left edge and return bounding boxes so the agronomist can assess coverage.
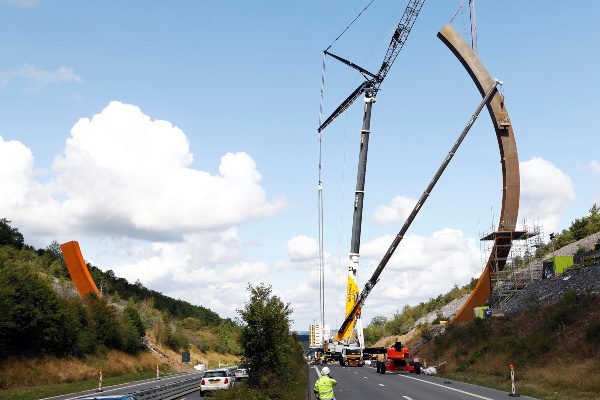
[0,64,83,92]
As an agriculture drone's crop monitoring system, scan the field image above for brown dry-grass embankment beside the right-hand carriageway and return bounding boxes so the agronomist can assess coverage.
[418,292,600,400]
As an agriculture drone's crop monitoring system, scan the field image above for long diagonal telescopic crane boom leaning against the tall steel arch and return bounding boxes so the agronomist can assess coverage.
[336,79,502,337]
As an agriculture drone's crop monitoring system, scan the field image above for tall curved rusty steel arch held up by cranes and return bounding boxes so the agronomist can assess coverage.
[437,24,521,324]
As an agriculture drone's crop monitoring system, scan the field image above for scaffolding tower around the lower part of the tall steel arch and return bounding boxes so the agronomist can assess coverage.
[480,221,544,312]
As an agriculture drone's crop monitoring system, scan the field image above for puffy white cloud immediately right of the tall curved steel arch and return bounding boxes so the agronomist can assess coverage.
[519,157,575,232]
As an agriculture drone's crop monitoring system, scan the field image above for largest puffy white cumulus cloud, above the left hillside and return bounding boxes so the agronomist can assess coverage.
[47,102,286,237]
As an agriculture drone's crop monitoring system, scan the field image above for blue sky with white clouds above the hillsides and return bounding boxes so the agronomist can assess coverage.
[0,0,600,330]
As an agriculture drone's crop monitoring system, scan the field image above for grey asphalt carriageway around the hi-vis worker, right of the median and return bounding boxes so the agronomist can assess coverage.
[309,364,531,400]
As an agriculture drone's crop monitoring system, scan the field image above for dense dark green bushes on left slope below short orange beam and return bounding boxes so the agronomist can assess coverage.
[0,263,149,356]
